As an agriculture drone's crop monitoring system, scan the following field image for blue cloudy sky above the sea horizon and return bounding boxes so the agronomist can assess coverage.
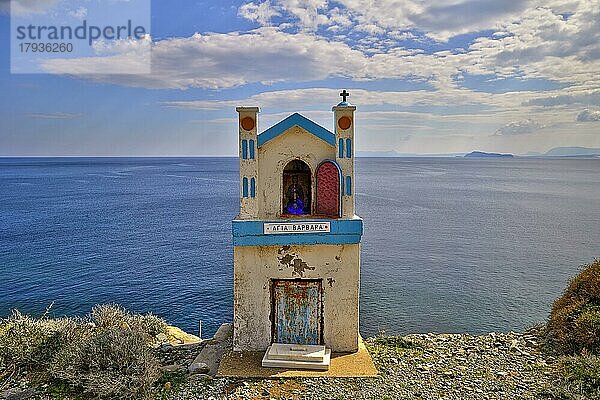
[0,0,600,156]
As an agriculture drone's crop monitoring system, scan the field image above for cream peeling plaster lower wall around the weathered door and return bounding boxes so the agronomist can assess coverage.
[233,244,360,352]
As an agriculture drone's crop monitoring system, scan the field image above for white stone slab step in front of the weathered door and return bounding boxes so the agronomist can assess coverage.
[262,343,331,371]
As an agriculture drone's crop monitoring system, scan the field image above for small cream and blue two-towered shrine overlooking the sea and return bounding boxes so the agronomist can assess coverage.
[233,90,363,370]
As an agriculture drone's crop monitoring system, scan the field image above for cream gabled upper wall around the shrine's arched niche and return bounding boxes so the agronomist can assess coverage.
[257,126,335,219]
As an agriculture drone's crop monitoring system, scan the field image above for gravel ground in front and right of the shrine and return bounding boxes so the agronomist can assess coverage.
[161,333,556,400]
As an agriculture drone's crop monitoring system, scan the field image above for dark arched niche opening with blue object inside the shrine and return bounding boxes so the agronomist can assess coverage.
[282,160,311,215]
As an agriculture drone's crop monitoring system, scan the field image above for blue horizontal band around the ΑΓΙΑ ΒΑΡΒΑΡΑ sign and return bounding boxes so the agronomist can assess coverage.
[232,219,363,246]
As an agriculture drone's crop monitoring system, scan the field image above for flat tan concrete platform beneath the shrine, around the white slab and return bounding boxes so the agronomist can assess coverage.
[217,339,377,378]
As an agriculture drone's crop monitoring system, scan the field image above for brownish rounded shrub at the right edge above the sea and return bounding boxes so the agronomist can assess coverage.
[547,260,600,354]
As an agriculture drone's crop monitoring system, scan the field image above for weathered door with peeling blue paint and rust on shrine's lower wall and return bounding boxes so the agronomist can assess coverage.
[273,279,322,344]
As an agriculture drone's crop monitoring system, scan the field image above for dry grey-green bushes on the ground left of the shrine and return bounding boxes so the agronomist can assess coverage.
[0,304,167,399]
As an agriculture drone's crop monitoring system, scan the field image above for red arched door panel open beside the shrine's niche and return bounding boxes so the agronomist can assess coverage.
[315,160,341,218]
